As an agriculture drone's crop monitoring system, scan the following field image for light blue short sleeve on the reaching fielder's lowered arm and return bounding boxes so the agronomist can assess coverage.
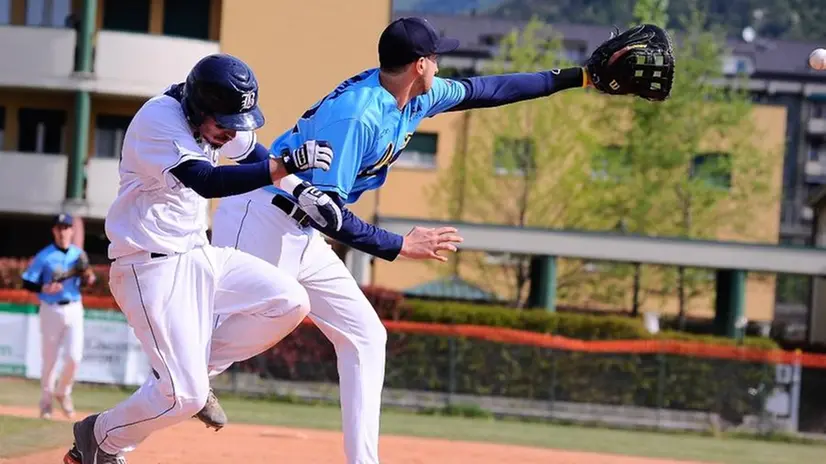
[310,119,372,200]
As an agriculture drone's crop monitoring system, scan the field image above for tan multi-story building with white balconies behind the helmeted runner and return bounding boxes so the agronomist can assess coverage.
[0,0,390,259]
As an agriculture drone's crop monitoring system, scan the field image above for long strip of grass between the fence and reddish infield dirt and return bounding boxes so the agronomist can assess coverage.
[0,379,826,464]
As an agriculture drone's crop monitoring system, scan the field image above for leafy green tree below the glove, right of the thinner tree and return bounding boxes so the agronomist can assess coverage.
[584,0,780,324]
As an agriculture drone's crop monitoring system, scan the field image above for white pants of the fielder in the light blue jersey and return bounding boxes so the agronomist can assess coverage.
[209,190,387,464]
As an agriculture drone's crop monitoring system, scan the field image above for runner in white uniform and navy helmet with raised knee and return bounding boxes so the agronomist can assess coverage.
[64,54,341,464]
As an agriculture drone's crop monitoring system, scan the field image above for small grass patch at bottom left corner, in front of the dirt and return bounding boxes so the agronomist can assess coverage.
[0,416,71,458]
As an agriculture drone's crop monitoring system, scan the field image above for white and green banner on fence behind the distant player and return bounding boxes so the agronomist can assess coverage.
[0,305,151,385]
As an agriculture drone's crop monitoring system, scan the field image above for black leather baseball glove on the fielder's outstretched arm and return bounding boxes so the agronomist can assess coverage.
[585,24,674,101]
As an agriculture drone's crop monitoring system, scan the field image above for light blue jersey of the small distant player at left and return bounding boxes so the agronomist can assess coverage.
[23,244,84,304]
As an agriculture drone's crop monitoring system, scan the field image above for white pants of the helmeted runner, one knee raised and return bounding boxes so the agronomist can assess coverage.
[95,246,309,454]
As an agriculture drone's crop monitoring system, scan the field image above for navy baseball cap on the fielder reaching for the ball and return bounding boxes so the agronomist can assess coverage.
[379,17,459,68]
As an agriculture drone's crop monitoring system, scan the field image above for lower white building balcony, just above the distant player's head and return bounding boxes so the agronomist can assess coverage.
[0,151,119,219]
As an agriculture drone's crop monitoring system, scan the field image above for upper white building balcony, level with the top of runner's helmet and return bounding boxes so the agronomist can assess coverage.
[0,26,220,98]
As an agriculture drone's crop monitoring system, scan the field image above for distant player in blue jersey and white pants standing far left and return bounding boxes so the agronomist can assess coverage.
[23,214,95,418]
